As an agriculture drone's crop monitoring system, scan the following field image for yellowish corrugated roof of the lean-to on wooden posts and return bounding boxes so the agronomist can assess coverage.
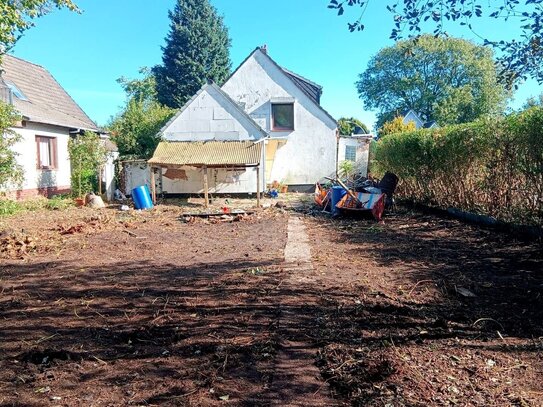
[149,141,262,167]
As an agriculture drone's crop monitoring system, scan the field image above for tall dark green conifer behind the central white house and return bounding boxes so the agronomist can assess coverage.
[153,0,231,108]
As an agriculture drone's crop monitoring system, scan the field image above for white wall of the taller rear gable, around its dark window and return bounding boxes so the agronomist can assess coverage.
[222,51,336,185]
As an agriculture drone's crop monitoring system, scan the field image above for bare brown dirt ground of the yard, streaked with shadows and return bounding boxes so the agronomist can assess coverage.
[0,199,543,407]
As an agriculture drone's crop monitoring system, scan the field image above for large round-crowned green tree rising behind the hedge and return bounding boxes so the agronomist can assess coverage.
[356,35,508,125]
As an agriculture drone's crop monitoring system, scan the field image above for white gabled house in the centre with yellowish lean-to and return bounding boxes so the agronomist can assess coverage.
[149,47,337,194]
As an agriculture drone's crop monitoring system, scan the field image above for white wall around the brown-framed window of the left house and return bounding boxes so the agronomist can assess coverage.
[9,122,71,190]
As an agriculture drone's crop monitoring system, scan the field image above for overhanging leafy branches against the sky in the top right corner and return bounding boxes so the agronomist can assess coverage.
[328,0,543,87]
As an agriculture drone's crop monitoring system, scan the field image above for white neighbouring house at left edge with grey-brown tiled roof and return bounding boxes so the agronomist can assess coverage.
[0,55,116,198]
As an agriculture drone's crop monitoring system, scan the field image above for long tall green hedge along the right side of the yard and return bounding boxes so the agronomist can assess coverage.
[373,107,543,226]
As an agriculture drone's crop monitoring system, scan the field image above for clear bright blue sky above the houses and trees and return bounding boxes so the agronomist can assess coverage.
[9,0,543,127]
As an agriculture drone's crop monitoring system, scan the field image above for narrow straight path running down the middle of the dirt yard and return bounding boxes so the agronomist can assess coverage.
[262,215,336,406]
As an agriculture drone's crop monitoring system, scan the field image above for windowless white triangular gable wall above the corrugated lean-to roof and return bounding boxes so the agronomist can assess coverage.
[163,85,263,141]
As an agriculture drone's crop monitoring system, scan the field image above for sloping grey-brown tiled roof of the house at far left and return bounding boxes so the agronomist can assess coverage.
[0,55,98,131]
